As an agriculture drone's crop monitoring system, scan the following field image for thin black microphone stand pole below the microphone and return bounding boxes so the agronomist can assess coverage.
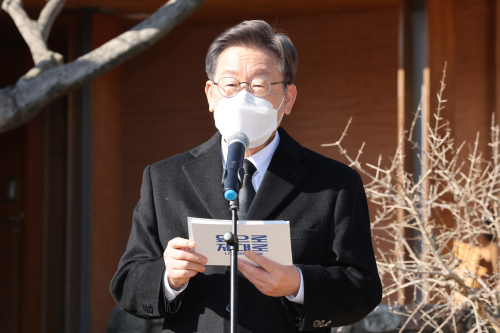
[224,198,239,333]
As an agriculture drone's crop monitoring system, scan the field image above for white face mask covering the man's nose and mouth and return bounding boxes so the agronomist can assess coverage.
[214,90,286,148]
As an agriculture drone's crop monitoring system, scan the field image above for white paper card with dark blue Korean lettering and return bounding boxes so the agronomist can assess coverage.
[188,217,293,266]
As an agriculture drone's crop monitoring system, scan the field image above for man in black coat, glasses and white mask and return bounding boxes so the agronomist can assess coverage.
[110,21,382,332]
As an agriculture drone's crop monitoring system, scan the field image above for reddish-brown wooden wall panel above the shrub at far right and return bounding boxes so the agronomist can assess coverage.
[451,1,495,157]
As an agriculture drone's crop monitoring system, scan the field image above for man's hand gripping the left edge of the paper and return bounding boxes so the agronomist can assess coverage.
[163,237,207,290]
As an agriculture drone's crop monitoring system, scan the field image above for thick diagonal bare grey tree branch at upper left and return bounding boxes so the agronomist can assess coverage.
[0,0,204,133]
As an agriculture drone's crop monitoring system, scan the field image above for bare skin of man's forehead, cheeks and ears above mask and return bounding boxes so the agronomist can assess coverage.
[205,46,297,124]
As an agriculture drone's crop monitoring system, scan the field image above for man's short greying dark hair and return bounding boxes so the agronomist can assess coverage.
[205,20,298,84]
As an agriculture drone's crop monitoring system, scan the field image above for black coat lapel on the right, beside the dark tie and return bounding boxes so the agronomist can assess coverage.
[246,128,309,220]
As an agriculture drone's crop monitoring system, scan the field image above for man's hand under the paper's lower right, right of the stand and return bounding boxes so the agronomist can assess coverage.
[238,251,300,297]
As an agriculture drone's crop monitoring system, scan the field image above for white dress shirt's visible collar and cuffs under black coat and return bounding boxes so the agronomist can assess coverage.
[164,131,304,304]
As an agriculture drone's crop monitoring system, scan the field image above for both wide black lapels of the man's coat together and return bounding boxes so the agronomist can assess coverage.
[183,127,309,220]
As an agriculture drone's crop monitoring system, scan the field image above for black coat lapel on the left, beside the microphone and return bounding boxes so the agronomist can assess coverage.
[183,132,231,220]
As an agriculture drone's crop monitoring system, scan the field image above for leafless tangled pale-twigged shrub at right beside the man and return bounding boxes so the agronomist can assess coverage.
[323,69,500,332]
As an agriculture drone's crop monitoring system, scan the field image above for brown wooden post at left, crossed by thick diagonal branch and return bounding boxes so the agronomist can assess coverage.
[89,14,121,332]
